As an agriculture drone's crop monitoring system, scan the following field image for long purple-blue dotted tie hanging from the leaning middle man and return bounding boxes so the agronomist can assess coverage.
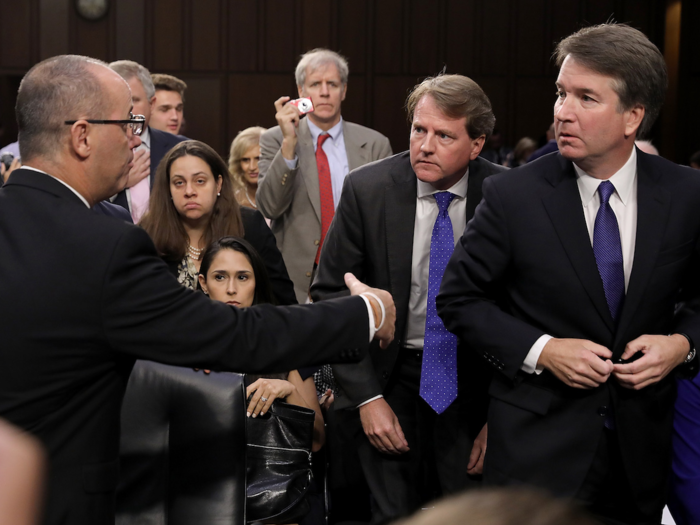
[420,192,457,414]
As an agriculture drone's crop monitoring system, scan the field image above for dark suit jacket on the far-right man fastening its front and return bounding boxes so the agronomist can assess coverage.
[437,151,700,512]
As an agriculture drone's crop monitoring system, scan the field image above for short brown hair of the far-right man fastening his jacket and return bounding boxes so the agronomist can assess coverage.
[554,24,668,138]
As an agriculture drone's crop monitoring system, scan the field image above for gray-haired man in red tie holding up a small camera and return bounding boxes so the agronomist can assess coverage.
[256,49,391,303]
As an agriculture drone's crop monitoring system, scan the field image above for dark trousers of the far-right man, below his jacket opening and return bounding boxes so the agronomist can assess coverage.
[576,428,663,525]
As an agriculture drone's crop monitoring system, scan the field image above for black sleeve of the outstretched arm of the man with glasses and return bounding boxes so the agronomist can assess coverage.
[101,228,369,373]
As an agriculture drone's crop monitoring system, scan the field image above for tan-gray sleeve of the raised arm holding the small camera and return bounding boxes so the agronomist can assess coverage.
[255,129,299,219]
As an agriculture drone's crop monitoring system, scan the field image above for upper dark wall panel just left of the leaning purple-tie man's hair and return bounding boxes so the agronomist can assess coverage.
[374,0,404,75]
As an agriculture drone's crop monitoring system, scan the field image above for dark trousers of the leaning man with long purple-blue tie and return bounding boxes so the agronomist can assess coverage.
[358,349,480,524]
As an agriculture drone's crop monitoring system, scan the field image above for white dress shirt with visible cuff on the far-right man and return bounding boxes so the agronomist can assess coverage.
[521,148,637,374]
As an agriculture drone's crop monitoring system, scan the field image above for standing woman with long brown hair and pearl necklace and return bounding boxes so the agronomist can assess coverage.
[139,140,296,304]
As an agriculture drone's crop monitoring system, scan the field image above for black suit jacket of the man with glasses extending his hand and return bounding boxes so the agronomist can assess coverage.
[0,170,368,525]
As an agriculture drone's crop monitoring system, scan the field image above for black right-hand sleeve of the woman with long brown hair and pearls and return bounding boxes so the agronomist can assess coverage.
[241,208,297,304]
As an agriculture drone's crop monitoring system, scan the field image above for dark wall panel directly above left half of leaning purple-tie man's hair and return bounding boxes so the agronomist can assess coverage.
[406,0,445,75]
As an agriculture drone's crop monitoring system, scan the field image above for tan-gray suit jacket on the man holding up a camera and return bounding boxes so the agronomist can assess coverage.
[256,119,391,303]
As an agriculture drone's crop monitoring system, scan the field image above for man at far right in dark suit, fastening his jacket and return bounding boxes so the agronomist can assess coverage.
[437,24,700,525]
